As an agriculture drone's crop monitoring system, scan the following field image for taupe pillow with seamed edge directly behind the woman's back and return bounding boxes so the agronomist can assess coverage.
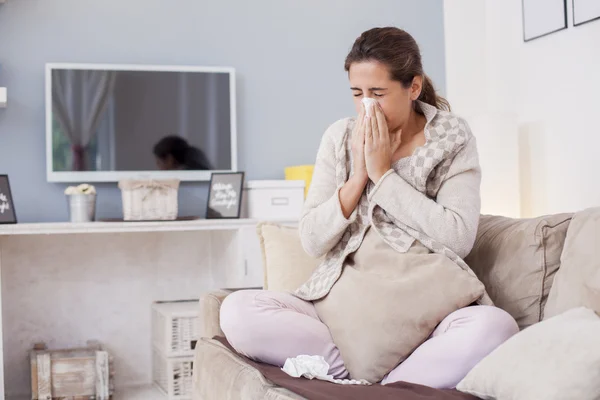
[465,214,572,329]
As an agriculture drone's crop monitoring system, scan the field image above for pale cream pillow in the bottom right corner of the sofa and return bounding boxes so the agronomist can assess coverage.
[457,307,600,400]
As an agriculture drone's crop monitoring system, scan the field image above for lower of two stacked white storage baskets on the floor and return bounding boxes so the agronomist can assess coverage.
[152,349,194,400]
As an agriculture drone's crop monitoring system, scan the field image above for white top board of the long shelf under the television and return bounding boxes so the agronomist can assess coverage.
[0,219,298,236]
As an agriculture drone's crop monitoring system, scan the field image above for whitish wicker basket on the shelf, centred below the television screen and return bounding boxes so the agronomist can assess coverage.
[119,179,179,221]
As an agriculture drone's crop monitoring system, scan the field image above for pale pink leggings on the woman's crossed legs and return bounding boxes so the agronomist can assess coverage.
[221,290,519,389]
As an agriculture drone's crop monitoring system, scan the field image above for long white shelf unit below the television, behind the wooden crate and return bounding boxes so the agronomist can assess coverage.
[0,219,297,400]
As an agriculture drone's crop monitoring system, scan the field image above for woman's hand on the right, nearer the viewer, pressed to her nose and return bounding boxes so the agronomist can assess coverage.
[365,105,402,183]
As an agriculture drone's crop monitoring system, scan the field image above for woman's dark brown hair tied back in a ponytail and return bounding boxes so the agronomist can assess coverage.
[344,27,450,110]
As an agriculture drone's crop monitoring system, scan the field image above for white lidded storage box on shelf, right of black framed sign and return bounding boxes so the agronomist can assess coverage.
[241,180,305,221]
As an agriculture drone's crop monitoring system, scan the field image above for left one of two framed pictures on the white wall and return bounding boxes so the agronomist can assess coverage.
[522,0,568,42]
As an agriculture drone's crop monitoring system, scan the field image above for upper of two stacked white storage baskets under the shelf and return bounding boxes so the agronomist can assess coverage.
[152,300,200,357]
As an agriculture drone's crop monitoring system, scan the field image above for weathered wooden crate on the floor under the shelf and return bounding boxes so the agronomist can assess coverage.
[29,342,113,400]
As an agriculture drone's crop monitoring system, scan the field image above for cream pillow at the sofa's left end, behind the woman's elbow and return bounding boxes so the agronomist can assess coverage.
[256,223,320,292]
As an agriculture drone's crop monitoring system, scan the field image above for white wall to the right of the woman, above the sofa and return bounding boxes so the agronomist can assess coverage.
[444,0,600,217]
